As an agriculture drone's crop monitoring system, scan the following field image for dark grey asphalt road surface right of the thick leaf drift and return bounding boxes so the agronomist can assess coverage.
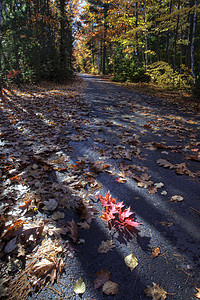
[37,74,200,300]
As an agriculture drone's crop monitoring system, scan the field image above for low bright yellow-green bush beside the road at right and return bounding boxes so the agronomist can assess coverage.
[147,61,194,89]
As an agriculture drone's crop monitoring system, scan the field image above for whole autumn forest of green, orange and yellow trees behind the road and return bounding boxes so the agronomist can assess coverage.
[0,0,200,93]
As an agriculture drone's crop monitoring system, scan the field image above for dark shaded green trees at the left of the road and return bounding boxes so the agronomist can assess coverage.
[1,0,73,83]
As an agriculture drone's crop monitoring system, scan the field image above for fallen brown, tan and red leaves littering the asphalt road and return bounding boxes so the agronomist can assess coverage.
[0,76,199,299]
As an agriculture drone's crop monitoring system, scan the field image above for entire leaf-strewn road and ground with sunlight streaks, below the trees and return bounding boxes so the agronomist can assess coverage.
[0,75,200,299]
